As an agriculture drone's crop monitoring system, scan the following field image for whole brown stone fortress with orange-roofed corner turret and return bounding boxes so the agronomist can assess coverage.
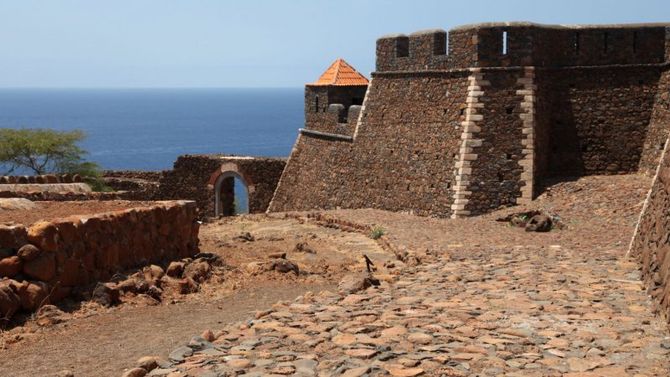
[269,22,670,217]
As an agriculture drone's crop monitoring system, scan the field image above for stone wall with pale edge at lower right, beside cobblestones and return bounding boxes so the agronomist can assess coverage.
[628,137,670,323]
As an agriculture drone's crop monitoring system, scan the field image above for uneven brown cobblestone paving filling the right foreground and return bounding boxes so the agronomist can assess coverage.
[136,246,670,377]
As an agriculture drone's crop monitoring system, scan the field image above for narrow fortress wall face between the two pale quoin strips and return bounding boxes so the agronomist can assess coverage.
[465,70,532,215]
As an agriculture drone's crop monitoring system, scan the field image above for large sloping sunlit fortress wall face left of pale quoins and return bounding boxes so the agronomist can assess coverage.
[269,72,468,216]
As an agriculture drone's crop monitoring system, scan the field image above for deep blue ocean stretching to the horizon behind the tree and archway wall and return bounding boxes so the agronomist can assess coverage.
[0,88,304,170]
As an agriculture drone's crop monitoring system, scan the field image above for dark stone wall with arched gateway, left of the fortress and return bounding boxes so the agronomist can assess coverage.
[156,155,286,216]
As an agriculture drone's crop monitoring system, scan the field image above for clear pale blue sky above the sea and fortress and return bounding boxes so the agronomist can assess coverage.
[0,0,670,87]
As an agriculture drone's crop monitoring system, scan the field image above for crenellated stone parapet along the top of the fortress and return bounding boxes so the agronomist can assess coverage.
[377,22,670,72]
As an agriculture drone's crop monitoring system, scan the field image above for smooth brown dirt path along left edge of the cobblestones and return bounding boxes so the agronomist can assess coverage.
[0,284,331,377]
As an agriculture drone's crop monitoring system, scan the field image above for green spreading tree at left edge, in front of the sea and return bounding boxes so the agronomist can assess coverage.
[0,128,109,189]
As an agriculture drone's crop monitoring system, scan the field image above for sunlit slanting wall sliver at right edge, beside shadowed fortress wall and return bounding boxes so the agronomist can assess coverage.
[639,68,670,174]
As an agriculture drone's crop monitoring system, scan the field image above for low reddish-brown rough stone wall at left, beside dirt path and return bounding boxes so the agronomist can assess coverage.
[0,201,199,319]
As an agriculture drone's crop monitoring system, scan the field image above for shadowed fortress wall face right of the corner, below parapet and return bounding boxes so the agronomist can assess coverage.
[538,66,659,176]
